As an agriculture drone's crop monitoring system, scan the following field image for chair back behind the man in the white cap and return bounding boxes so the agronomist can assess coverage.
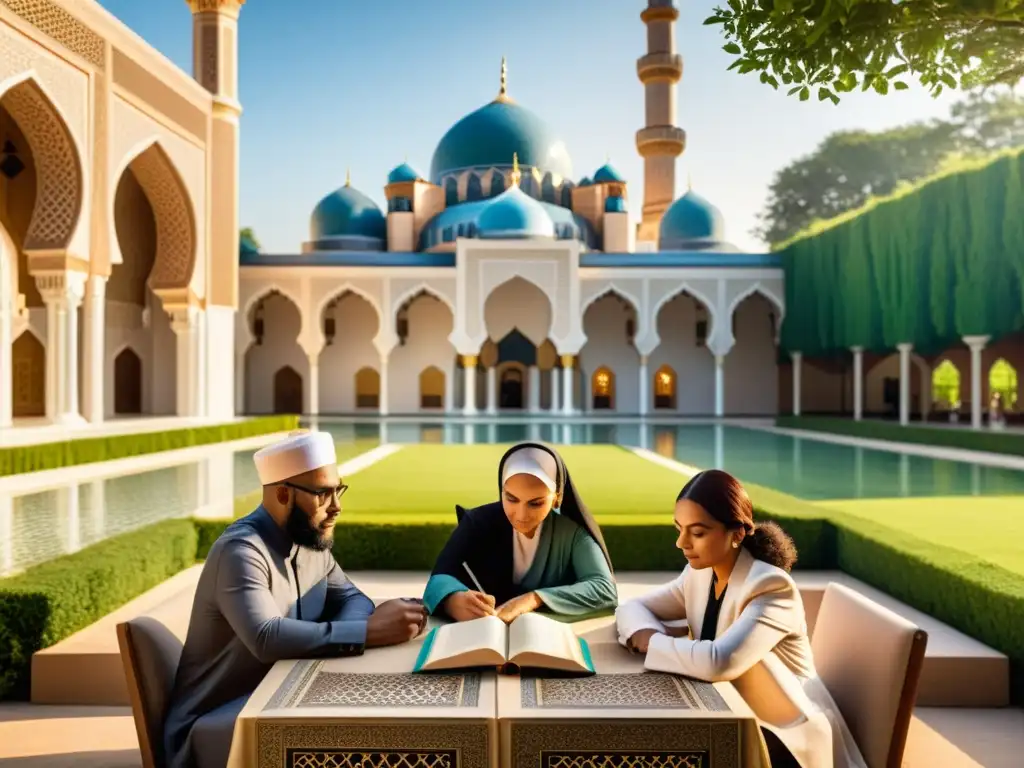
[117,616,182,768]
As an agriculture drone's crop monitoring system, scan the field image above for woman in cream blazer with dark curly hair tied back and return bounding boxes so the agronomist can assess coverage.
[615,469,866,768]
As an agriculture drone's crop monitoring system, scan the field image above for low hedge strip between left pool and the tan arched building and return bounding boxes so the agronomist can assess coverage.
[0,416,299,477]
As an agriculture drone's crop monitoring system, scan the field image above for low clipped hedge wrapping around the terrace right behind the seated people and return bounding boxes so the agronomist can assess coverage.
[6,501,1024,705]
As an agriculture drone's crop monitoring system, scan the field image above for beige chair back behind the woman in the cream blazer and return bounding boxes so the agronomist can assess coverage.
[811,582,928,768]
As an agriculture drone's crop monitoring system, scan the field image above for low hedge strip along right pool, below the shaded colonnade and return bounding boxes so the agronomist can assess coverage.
[775,416,1024,456]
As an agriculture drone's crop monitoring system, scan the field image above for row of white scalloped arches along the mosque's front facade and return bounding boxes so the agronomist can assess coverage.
[236,276,779,416]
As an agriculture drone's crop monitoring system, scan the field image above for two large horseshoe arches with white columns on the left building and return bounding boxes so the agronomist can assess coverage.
[0,79,214,427]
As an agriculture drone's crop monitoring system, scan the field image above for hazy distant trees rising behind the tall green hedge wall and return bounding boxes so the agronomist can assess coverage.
[753,91,1024,247]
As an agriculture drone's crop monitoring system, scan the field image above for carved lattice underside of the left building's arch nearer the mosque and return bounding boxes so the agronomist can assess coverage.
[129,143,196,291]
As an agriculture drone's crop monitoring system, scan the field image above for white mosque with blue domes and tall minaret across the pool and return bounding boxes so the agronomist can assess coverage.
[234,0,784,416]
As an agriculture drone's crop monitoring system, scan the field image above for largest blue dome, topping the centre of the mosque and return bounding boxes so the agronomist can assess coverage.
[430,98,572,184]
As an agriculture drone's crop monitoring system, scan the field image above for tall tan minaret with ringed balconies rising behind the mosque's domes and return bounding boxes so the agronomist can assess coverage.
[637,0,686,243]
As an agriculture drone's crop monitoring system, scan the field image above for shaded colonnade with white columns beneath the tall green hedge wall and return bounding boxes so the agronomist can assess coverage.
[779,333,1024,427]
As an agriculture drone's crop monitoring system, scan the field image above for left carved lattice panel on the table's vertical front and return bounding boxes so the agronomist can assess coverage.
[260,715,492,768]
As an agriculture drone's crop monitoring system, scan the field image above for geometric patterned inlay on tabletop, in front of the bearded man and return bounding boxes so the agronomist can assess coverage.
[264,659,481,708]
